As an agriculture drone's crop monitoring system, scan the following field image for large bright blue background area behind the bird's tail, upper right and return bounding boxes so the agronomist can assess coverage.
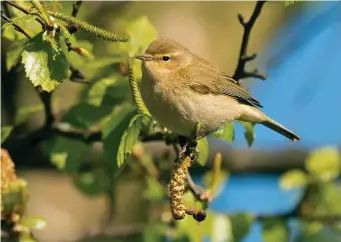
[235,2,341,149]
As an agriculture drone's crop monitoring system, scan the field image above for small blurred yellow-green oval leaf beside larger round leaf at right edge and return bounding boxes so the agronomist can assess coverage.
[280,169,308,190]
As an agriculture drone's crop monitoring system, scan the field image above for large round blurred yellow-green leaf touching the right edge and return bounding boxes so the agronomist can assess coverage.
[306,147,341,181]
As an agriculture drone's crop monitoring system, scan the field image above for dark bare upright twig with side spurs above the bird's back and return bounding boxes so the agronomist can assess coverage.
[233,1,266,81]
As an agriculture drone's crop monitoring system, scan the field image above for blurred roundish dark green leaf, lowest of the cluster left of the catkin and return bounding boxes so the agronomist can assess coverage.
[73,169,110,196]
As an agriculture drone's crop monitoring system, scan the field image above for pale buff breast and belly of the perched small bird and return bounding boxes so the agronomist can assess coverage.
[141,73,240,137]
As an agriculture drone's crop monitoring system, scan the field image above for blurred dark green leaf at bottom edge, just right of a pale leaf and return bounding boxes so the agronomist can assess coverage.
[229,213,254,242]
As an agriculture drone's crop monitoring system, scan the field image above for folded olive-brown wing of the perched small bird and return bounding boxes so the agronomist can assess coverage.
[180,63,263,108]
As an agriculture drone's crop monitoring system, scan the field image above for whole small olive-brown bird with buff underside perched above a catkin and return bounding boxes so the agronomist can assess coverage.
[136,39,300,141]
